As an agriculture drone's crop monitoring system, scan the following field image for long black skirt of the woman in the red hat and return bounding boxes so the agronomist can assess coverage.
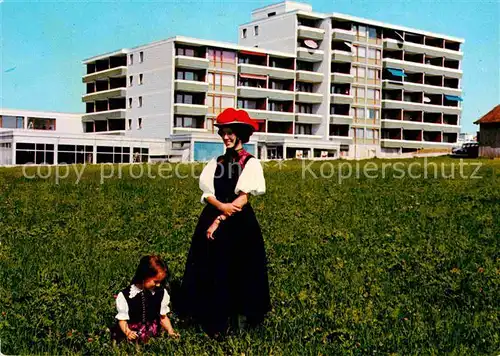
[182,203,270,333]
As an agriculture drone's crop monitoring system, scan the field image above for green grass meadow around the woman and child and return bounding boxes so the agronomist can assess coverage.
[0,158,500,355]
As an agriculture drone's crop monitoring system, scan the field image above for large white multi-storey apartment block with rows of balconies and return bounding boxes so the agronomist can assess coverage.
[83,2,463,160]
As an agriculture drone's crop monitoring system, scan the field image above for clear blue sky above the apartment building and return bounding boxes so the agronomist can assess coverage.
[0,0,500,132]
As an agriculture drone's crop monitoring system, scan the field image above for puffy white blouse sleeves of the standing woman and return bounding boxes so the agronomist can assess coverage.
[200,157,266,203]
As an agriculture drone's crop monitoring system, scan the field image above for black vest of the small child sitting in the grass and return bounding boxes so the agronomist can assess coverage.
[122,287,165,323]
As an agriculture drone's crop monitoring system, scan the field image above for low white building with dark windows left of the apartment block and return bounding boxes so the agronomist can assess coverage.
[0,109,170,166]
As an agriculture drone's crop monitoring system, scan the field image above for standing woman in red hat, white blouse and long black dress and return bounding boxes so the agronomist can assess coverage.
[182,108,270,336]
